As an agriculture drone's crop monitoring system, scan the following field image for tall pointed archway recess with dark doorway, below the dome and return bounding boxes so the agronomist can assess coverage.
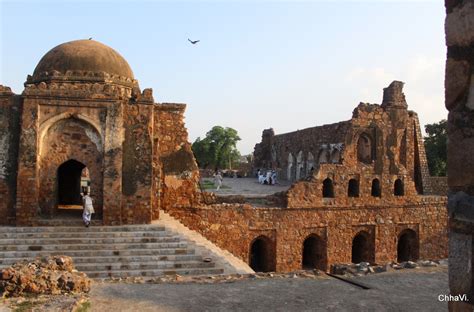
[38,117,104,216]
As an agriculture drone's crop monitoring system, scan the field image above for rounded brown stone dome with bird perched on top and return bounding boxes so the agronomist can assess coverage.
[31,40,134,82]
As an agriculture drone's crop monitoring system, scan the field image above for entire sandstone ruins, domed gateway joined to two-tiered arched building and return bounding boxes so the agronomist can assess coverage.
[0,40,447,271]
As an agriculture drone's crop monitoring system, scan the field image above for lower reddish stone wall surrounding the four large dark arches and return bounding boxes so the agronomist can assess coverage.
[170,196,447,271]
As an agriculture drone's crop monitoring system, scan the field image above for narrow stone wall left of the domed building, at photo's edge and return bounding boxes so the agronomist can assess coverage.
[0,85,21,224]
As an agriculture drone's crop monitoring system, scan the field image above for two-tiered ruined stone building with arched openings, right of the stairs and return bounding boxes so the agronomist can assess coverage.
[161,81,448,271]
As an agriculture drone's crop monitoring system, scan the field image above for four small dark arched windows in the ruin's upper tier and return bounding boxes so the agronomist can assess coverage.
[322,178,405,198]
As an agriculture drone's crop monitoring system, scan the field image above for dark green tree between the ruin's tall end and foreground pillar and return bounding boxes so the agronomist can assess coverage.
[424,119,448,176]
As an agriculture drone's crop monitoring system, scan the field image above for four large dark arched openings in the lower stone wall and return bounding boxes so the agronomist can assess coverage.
[249,229,419,272]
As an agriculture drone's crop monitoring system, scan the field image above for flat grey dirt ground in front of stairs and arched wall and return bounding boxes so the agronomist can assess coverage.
[91,268,449,312]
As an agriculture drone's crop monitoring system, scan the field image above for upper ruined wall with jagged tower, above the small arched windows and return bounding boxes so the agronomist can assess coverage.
[254,81,433,194]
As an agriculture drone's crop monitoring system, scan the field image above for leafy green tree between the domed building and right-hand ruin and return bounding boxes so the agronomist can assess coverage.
[192,126,240,169]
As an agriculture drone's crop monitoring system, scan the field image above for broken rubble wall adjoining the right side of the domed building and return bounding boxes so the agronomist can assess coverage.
[154,103,200,210]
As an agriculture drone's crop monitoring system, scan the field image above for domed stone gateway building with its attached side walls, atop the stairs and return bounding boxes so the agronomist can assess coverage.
[0,40,198,225]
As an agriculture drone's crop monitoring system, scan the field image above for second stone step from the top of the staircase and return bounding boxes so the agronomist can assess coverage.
[0,231,174,240]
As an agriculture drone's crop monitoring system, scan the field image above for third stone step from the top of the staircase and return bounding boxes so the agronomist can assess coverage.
[0,236,180,246]
